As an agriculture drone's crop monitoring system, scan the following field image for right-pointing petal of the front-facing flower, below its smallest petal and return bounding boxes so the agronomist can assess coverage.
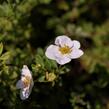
[69,49,84,59]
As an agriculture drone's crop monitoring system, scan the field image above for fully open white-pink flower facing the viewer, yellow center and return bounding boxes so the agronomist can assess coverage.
[45,35,83,65]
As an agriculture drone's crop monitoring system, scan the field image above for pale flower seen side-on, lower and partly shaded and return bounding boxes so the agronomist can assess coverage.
[16,65,34,100]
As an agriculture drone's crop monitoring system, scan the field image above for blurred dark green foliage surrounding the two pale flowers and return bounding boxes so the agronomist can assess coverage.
[0,0,109,109]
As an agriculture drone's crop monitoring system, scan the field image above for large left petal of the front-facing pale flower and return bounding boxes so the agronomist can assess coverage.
[45,45,59,60]
